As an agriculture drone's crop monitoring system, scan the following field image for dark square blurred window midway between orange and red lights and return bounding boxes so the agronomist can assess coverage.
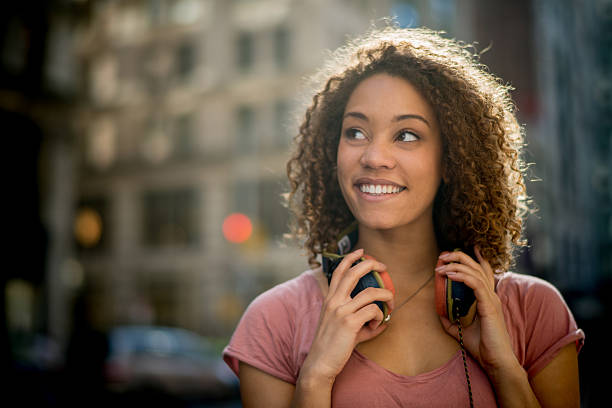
[143,189,198,248]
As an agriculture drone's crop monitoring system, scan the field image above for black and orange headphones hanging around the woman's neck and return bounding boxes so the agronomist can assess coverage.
[321,221,476,326]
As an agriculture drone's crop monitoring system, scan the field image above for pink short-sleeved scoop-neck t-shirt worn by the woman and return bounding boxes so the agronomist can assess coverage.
[223,271,584,408]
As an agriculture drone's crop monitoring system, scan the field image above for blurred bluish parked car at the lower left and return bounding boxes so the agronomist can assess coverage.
[104,325,239,402]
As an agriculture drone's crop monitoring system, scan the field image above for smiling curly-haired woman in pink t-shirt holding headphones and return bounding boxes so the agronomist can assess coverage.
[224,27,584,407]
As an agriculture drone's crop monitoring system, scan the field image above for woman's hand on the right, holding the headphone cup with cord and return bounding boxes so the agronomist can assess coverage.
[436,246,518,376]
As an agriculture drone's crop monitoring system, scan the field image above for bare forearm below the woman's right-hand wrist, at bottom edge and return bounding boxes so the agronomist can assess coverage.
[488,361,541,408]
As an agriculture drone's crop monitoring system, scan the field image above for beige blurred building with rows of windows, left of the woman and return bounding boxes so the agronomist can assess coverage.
[67,0,396,335]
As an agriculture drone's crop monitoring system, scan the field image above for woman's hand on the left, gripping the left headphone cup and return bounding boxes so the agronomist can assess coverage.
[300,249,393,384]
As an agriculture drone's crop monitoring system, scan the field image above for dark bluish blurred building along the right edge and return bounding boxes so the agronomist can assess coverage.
[531,0,612,294]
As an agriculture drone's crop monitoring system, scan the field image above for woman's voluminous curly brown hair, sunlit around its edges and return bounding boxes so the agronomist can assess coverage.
[287,27,529,270]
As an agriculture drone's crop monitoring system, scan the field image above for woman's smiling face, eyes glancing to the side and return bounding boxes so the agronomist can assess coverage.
[337,74,442,233]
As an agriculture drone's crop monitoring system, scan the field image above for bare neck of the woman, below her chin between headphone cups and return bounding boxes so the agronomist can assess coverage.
[354,223,440,293]
